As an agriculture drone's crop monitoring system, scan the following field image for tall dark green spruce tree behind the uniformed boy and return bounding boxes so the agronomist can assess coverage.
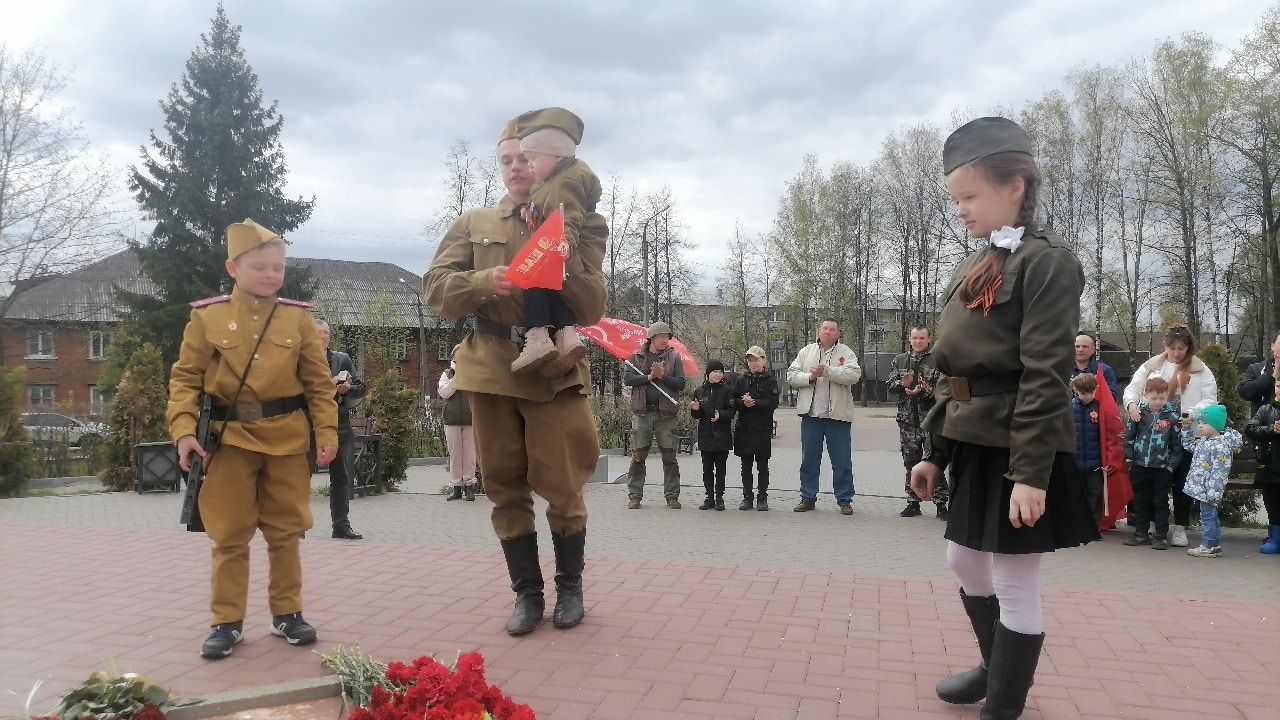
[119,4,315,363]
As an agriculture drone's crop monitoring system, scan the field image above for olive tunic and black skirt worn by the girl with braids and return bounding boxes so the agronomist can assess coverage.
[923,228,1098,553]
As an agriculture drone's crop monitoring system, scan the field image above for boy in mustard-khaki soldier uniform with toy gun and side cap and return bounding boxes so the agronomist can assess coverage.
[168,220,338,660]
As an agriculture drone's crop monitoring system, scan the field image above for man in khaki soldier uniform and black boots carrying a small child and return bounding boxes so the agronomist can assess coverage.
[422,115,608,635]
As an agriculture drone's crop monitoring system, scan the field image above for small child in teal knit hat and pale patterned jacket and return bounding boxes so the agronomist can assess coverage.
[1181,405,1240,557]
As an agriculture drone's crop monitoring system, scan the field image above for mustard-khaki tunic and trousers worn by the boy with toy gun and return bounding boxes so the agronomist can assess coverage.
[166,287,338,625]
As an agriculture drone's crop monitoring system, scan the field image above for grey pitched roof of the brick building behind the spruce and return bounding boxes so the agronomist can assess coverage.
[5,250,434,328]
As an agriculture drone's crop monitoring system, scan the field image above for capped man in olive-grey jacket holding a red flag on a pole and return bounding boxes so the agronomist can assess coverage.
[622,322,685,510]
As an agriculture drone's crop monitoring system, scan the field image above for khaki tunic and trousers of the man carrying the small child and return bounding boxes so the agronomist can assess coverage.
[422,197,605,539]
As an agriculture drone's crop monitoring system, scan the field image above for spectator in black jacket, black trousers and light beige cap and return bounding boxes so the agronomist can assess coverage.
[731,345,778,511]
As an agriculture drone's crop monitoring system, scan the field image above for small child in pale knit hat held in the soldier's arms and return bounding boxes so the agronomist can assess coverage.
[511,108,609,379]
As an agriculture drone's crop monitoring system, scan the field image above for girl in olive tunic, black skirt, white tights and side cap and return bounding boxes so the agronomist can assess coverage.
[911,118,1098,720]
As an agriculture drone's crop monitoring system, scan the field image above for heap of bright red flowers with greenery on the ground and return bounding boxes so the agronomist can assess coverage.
[325,648,535,720]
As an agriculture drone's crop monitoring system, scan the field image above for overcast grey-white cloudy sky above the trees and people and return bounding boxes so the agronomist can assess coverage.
[0,0,1270,292]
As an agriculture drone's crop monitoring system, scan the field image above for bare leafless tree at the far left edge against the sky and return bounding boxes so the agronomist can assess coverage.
[0,45,120,316]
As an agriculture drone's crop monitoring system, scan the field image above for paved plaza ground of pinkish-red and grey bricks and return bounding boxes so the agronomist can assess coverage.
[0,413,1280,720]
